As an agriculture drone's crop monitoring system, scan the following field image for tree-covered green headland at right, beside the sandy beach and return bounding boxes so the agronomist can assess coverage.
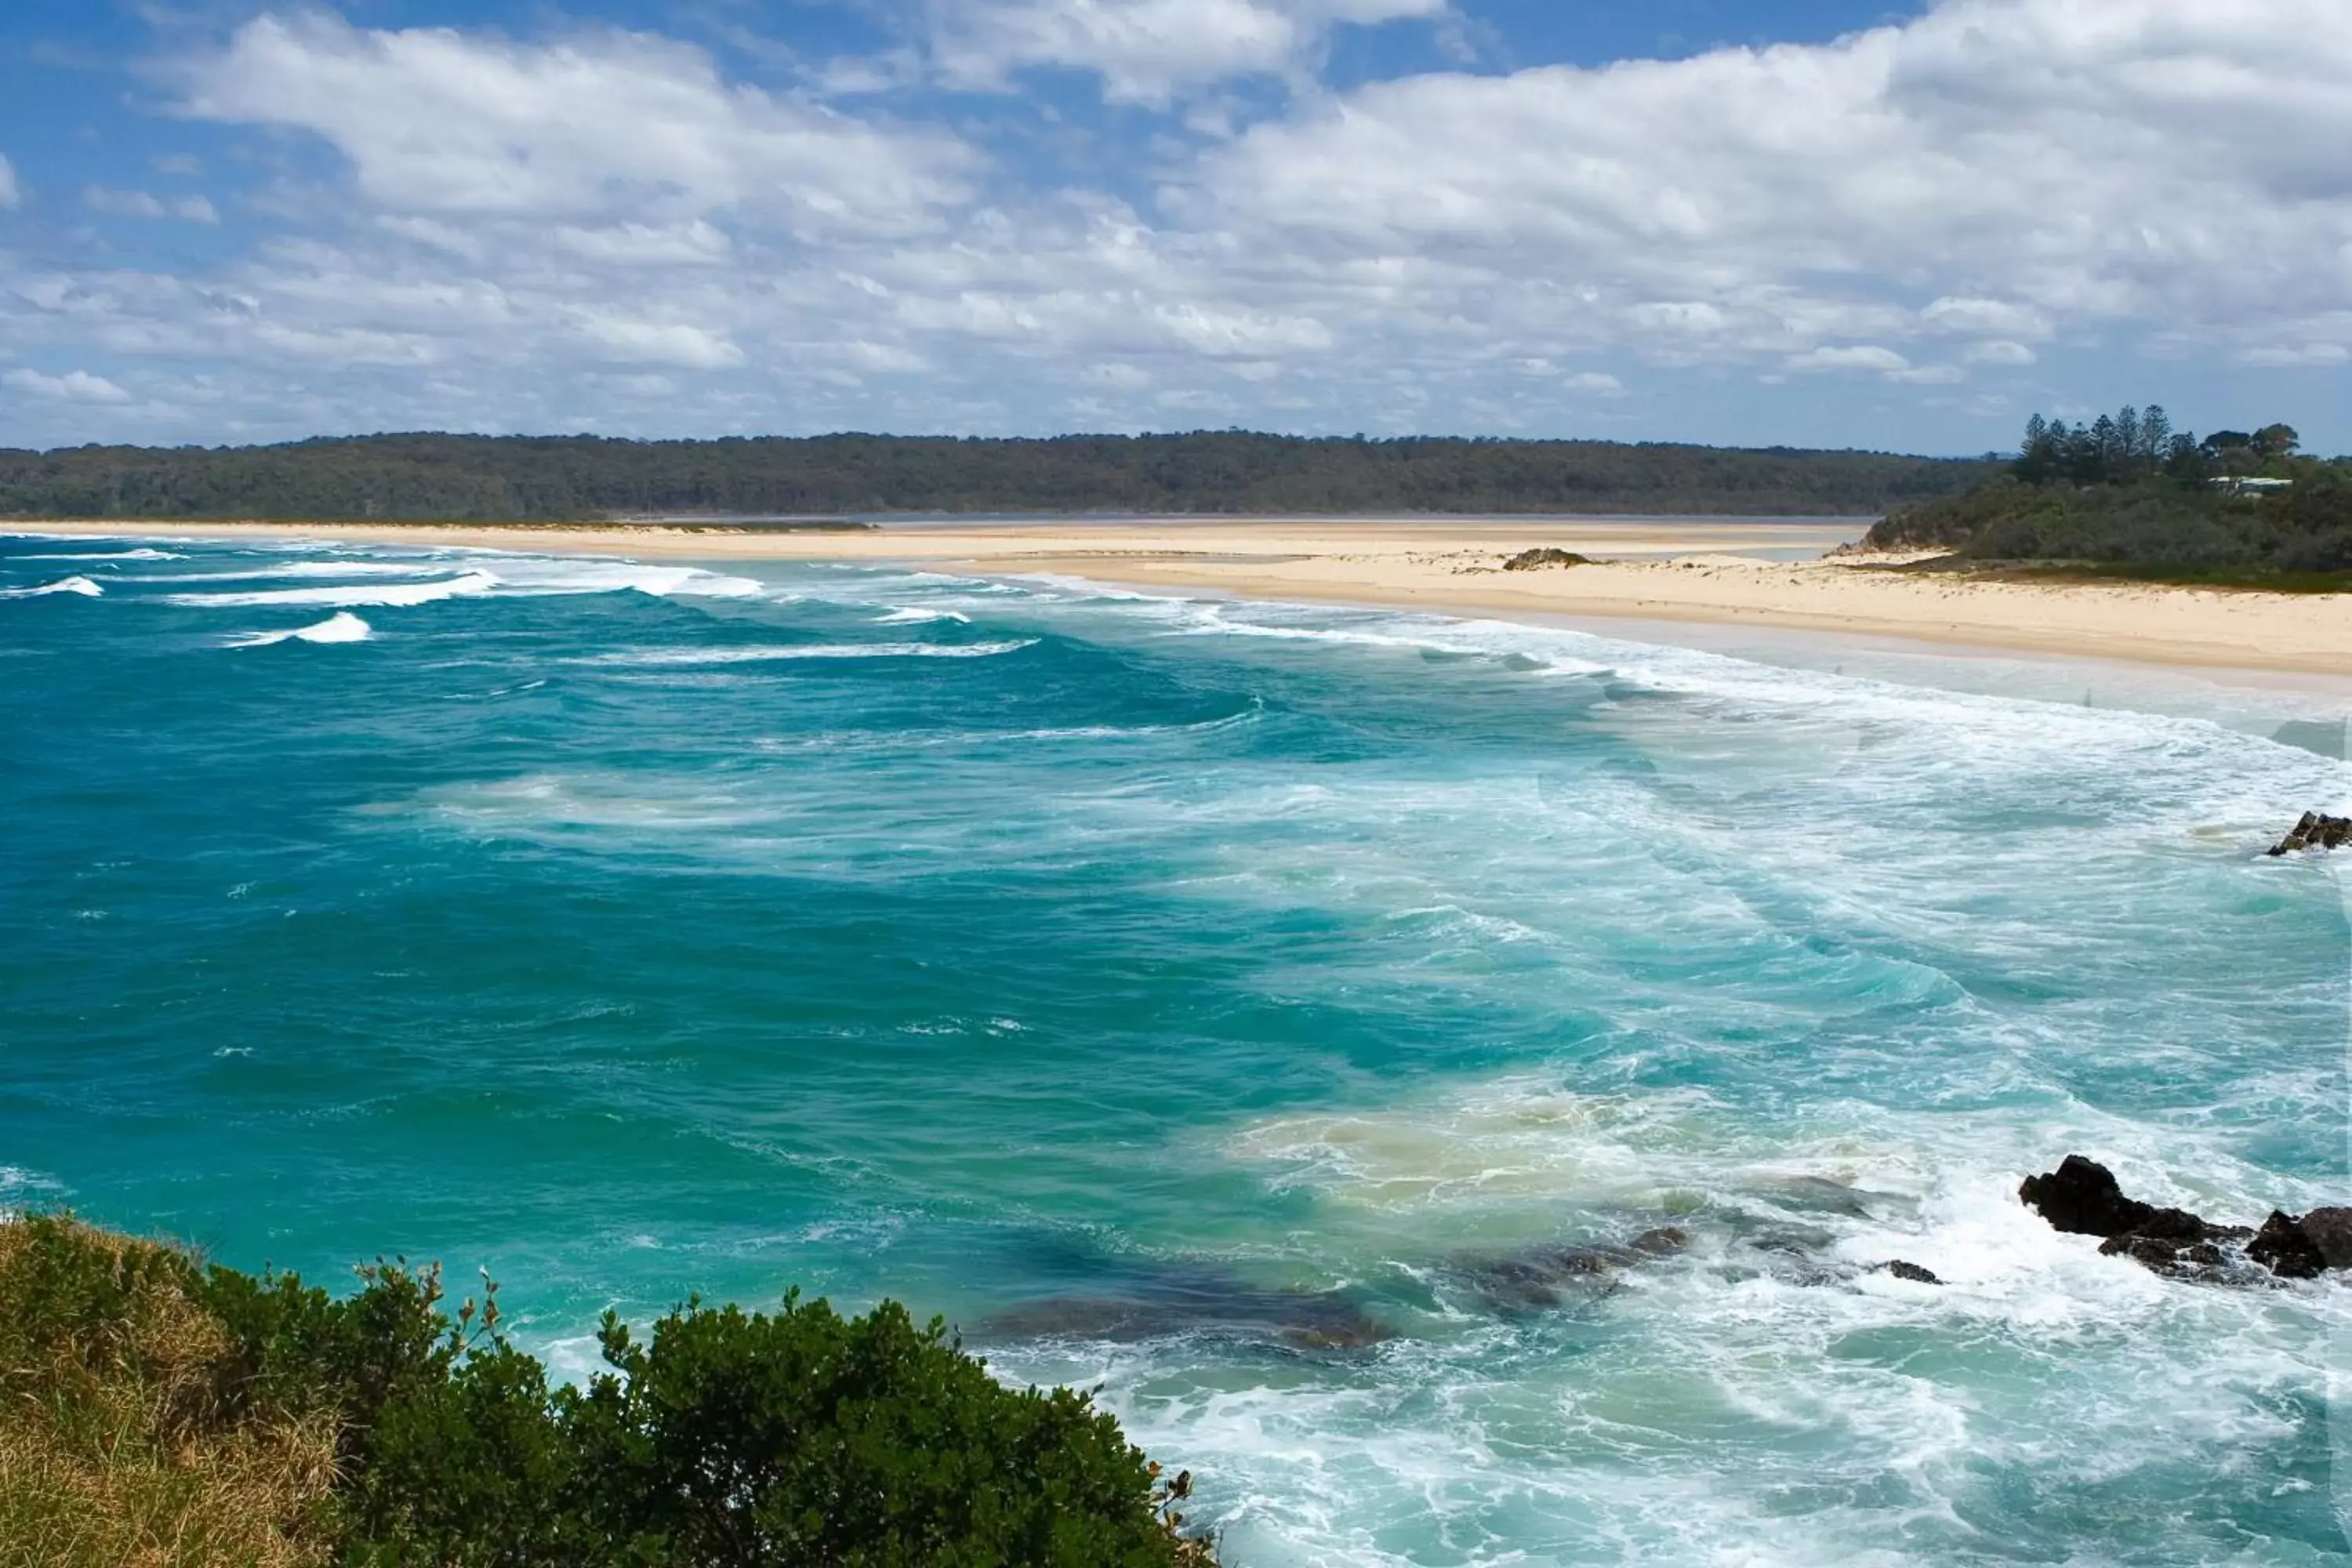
[1865,407,2352,576]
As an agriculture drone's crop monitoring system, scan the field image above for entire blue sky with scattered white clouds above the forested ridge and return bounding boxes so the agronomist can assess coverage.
[0,0,2352,452]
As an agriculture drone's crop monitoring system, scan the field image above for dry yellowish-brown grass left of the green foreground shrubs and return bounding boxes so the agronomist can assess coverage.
[0,1218,336,1568]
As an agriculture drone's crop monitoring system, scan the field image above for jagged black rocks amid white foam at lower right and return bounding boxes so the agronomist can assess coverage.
[2018,1154,2352,1283]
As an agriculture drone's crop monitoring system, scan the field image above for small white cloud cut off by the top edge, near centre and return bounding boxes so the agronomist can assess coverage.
[934,0,1446,106]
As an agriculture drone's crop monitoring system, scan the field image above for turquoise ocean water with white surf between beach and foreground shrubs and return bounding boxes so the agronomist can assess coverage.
[0,536,2352,1568]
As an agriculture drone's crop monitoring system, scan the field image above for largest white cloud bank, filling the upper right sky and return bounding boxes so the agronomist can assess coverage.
[1169,0,2352,353]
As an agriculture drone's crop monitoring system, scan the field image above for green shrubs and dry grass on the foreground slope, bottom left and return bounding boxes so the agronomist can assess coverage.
[0,1215,1214,1568]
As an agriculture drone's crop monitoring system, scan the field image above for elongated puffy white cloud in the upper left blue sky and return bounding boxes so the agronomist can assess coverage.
[183,16,978,233]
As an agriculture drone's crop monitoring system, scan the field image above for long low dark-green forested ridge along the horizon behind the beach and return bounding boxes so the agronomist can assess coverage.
[0,433,1992,520]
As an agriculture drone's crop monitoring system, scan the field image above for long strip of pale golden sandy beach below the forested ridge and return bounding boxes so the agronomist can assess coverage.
[16,517,2352,675]
